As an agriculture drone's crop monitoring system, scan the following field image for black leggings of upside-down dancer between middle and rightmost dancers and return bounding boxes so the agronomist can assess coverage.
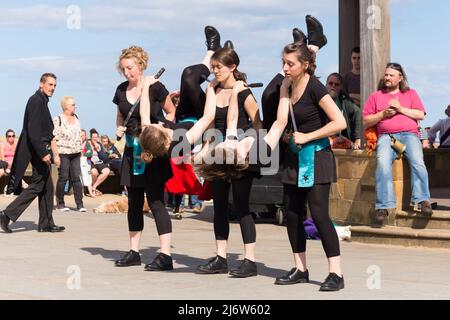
[261,73,284,130]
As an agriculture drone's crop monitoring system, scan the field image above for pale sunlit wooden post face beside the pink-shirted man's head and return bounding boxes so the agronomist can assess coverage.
[360,0,391,107]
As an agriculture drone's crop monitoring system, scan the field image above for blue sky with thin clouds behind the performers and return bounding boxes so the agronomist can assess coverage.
[0,0,450,135]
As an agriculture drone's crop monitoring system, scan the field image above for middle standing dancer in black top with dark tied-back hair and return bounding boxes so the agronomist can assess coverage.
[194,48,261,277]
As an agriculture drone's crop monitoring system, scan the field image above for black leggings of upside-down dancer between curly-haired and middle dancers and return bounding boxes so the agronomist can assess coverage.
[176,64,210,120]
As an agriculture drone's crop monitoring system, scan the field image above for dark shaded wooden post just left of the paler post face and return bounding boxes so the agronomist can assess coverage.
[339,0,360,75]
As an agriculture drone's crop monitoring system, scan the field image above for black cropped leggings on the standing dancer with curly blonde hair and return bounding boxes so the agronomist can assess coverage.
[127,184,172,235]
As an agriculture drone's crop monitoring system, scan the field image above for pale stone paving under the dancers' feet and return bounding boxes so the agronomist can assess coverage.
[0,195,450,300]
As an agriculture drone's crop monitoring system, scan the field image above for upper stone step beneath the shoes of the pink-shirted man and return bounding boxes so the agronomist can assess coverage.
[395,210,450,230]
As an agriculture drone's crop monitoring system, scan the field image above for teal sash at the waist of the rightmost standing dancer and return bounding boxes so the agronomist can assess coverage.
[298,138,330,188]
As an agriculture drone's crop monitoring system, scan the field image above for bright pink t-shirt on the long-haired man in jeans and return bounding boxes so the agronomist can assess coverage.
[363,89,425,135]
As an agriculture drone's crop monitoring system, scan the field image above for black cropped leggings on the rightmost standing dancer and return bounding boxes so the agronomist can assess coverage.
[284,184,340,258]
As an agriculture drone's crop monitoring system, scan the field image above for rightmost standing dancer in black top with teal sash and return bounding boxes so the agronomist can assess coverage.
[275,42,346,291]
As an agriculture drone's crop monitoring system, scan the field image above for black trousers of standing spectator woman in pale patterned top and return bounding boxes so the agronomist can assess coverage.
[56,153,83,207]
